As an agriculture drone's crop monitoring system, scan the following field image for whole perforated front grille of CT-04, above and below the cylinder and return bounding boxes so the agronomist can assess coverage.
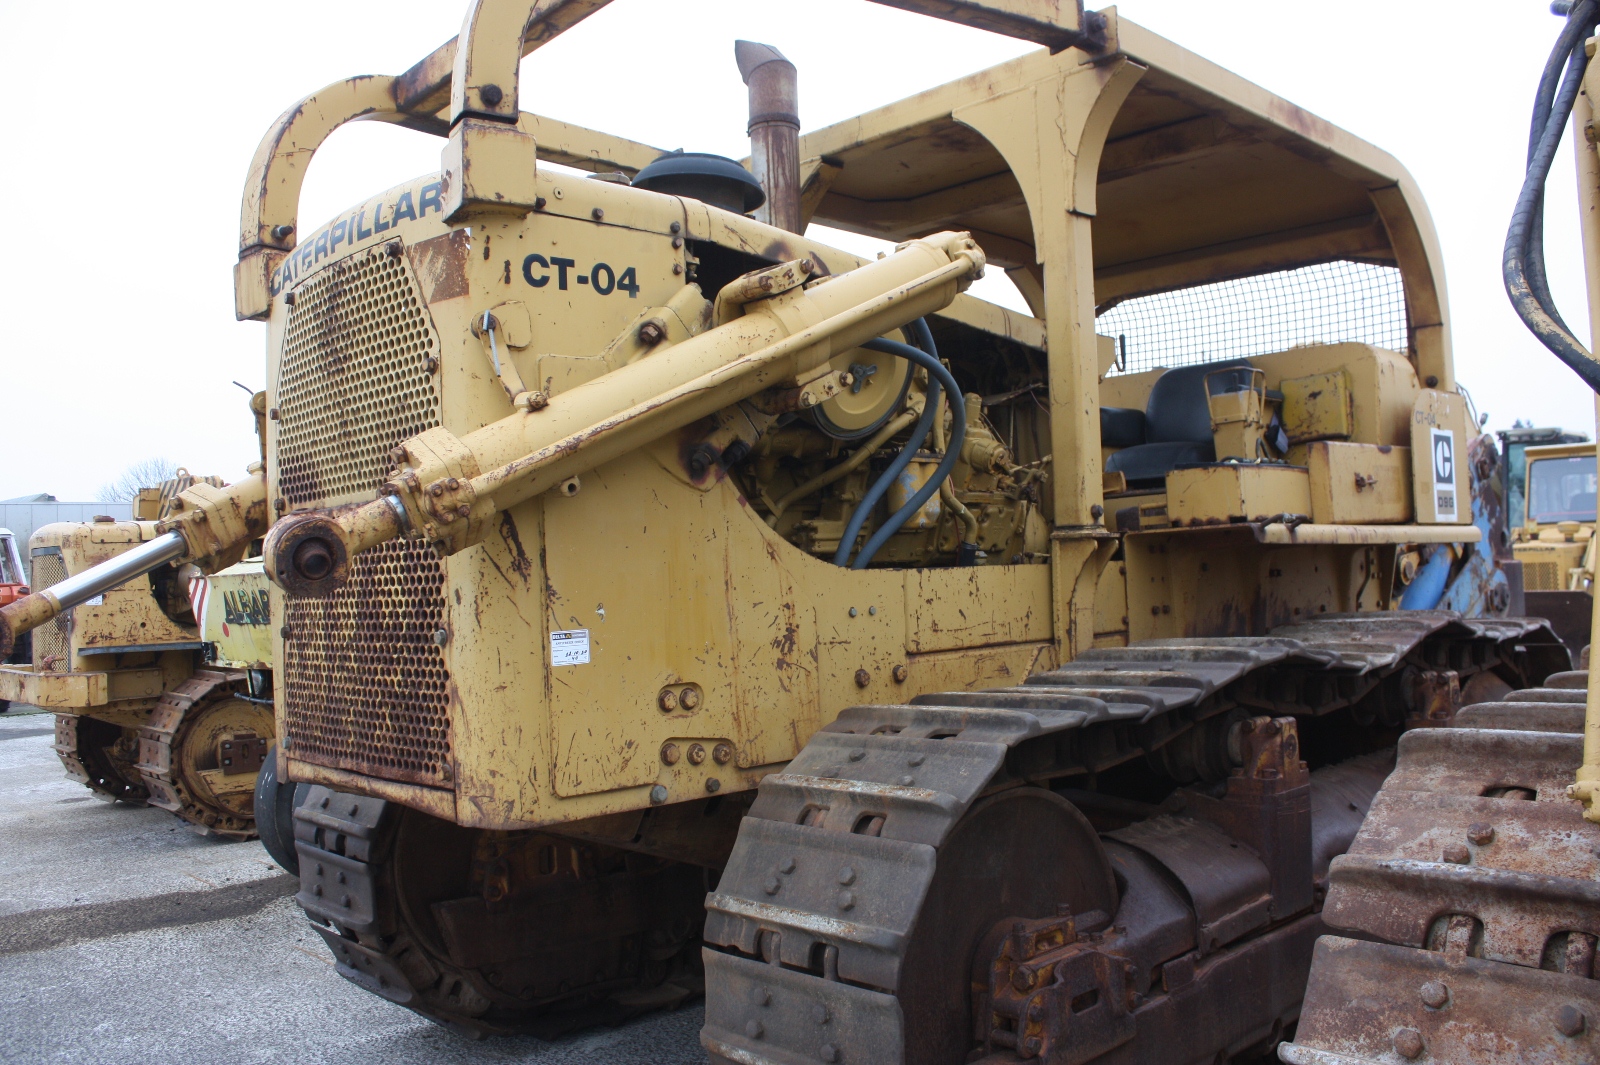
[274,243,451,787]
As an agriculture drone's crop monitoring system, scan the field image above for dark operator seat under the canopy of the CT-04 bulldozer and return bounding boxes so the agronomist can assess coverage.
[1101,358,1250,488]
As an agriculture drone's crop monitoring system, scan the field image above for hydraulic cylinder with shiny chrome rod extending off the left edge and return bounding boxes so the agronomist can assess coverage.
[0,462,267,657]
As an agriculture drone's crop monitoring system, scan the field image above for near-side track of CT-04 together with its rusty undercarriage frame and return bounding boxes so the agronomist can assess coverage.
[702,612,1555,1063]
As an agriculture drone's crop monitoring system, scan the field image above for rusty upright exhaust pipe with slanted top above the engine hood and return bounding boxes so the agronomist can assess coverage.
[733,40,803,233]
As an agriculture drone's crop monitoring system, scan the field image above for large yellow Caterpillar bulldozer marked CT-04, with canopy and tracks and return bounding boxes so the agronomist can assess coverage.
[0,0,1570,1065]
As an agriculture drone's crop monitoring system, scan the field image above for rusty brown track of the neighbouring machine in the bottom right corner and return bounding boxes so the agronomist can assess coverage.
[1280,673,1600,1065]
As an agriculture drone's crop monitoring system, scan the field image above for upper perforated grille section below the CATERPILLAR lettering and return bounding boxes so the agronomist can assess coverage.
[275,245,438,507]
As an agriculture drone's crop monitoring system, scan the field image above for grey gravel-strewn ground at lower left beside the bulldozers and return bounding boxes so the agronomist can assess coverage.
[0,707,704,1065]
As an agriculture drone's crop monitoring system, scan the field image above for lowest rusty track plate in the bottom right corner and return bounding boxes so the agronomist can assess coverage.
[1280,935,1600,1065]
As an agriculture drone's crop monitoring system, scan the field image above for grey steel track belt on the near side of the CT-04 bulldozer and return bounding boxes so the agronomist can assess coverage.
[701,612,1565,1065]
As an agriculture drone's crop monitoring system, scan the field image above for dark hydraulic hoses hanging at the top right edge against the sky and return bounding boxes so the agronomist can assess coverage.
[1501,0,1600,393]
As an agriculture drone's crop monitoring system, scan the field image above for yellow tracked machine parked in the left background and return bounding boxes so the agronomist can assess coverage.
[0,444,274,840]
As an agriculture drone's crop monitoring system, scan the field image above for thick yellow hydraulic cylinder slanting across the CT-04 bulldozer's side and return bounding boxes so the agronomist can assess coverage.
[264,233,984,595]
